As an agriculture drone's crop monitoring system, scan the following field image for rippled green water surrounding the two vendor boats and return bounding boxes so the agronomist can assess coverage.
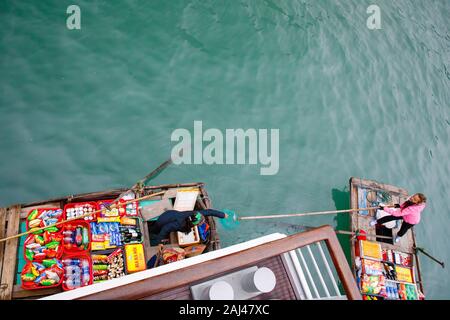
[0,0,450,298]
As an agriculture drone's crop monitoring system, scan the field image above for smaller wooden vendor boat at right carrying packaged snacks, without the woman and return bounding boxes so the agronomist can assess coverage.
[349,177,424,300]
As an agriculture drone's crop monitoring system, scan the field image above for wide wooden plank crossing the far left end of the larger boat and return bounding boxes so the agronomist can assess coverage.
[0,205,20,300]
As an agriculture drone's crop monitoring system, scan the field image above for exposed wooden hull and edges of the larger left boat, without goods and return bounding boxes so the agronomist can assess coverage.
[0,183,220,300]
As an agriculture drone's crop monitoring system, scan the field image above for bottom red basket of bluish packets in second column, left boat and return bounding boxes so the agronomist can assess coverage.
[62,253,93,291]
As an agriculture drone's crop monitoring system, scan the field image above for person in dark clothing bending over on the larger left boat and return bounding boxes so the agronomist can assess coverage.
[150,209,228,245]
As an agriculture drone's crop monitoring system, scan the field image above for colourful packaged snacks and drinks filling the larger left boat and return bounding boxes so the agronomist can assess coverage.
[21,195,209,291]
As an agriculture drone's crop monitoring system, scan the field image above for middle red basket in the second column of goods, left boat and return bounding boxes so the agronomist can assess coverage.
[62,220,91,253]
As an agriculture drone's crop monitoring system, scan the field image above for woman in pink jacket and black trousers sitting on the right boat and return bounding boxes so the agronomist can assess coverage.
[370,193,427,243]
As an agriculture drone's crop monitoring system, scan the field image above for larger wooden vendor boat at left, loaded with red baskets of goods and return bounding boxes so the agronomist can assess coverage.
[0,183,220,300]
